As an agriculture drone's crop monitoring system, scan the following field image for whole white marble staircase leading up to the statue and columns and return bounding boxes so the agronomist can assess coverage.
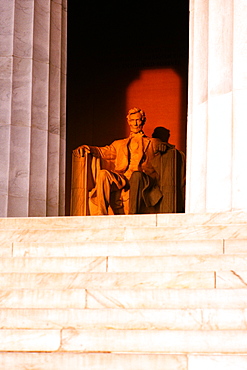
[0,212,247,370]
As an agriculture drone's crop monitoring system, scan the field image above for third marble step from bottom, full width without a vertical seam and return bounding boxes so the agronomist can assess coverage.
[0,308,247,330]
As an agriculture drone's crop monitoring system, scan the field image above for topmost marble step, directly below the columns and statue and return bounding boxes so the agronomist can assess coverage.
[0,211,247,230]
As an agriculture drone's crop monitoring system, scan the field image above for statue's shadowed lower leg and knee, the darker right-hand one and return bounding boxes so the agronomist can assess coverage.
[129,171,149,215]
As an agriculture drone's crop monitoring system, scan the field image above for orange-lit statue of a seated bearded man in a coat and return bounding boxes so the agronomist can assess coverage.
[73,108,184,215]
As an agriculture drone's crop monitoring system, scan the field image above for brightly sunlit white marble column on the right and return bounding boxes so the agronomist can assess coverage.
[186,0,247,213]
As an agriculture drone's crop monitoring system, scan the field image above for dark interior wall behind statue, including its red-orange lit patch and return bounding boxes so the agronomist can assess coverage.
[66,0,189,215]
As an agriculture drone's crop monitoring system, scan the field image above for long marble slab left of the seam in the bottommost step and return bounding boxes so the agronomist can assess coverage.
[0,352,187,370]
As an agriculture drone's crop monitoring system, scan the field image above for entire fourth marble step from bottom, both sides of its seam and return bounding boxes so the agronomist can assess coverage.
[0,288,247,310]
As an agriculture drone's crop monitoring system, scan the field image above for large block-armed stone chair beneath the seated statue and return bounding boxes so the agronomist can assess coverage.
[70,148,185,216]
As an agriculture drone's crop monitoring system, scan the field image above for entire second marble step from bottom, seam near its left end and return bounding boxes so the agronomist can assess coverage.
[0,329,247,354]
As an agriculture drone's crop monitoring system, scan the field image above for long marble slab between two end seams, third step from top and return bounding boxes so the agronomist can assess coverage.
[13,240,223,257]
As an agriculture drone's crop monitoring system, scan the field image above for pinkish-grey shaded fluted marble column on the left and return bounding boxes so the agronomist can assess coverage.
[0,0,67,217]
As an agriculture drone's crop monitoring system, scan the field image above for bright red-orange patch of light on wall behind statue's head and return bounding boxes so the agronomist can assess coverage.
[126,68,185,150]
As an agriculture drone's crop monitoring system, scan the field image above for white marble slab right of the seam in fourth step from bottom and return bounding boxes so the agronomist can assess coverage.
[86,289,247,309]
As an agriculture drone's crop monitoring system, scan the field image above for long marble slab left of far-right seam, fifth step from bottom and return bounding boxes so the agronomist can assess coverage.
[0,271,215,294]
